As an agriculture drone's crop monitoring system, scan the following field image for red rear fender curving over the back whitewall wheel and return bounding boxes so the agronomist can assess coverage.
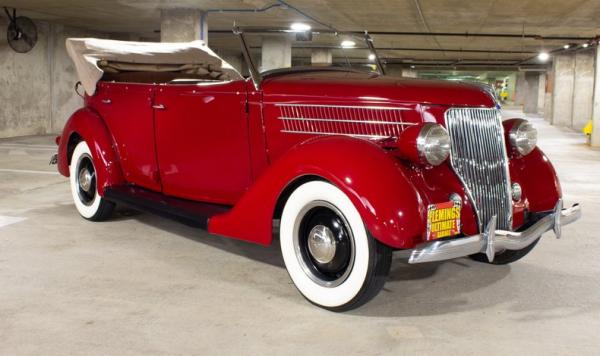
[58,108,125,195]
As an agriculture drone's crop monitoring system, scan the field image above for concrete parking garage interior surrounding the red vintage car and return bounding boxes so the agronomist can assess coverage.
[0,0,600,355]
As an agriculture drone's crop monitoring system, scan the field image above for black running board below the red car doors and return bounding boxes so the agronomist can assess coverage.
[104,185,231,230]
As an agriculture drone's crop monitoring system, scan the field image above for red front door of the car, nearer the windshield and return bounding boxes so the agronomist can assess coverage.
[154,80,251,204]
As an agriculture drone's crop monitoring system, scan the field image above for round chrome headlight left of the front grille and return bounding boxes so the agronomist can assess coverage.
[417,123,450,166]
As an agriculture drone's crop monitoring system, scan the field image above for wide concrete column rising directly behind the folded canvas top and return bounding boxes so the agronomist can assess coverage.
[160,9,208,43]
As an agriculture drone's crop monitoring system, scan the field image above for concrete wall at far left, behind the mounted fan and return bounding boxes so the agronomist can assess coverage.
[0,18,106,137]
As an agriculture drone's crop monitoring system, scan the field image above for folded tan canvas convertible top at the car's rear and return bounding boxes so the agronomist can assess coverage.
[67,38,242,95]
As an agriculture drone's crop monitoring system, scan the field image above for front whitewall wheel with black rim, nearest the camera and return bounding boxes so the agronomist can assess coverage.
[280,181,392,311]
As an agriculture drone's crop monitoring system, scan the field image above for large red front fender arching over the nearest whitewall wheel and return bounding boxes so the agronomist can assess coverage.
[209,136,425,248]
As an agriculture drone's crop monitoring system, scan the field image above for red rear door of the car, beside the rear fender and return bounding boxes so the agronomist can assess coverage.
[90,82,161,192]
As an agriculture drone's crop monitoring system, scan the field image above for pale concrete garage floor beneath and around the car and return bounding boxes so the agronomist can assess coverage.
[0,113,600,356]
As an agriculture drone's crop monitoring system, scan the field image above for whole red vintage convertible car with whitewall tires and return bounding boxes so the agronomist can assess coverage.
[57,34,581,311]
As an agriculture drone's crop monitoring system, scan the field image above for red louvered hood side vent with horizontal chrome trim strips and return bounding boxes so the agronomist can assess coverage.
[276,104,415,139]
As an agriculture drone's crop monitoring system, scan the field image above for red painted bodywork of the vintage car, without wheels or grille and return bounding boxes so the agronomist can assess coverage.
[58,70,561,249]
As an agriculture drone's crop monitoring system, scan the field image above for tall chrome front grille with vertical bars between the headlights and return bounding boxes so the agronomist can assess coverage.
[445,108,512,230]
